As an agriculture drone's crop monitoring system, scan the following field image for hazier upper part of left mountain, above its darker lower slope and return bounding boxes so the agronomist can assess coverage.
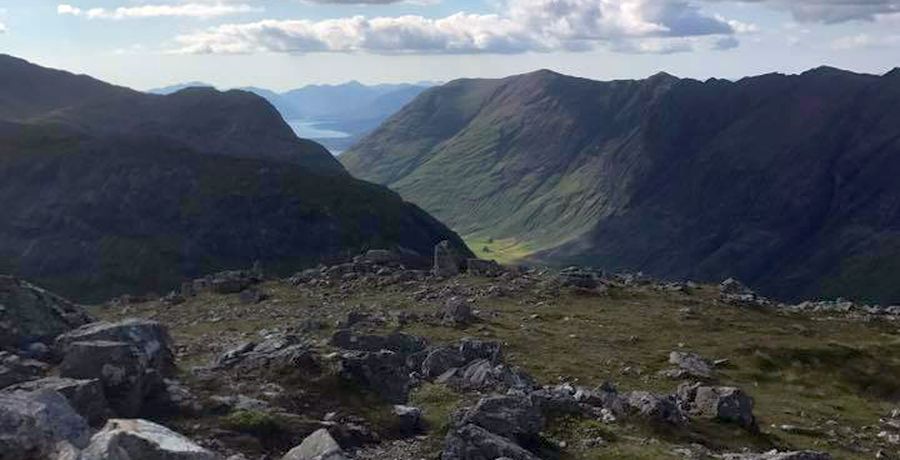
[0,55,345,174]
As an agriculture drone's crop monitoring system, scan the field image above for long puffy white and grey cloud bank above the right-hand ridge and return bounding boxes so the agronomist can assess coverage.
[173,0,750,54]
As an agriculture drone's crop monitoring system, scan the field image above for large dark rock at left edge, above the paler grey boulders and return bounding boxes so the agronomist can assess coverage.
[0,276,91,348]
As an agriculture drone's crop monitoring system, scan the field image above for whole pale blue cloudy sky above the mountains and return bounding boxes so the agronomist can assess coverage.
[0,0,900,90]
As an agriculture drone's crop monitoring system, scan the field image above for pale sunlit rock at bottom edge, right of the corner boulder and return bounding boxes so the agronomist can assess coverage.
[81,419,222,460]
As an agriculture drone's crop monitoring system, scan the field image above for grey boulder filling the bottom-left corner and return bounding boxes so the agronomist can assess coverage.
[0,390,90,460]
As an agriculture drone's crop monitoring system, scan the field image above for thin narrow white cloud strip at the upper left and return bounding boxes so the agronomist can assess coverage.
[56,3,263,19]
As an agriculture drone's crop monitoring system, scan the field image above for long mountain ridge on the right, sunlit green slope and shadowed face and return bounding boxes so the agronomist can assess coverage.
[341,68,900,302]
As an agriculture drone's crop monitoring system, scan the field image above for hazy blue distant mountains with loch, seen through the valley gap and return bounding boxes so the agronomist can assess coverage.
[149,81,433,152]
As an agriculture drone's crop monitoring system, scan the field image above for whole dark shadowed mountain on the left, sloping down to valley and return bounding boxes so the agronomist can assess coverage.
[0,58,466,300]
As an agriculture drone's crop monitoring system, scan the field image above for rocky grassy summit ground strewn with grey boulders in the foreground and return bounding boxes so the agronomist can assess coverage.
[0,250,900,460]
